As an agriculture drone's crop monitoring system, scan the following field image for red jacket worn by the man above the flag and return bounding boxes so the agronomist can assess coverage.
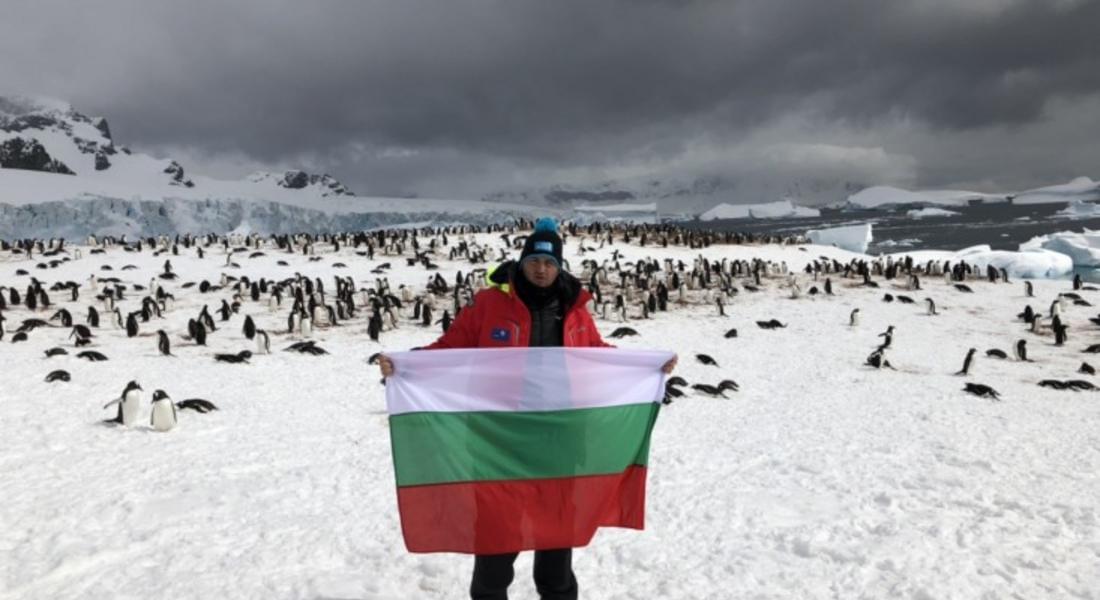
[424,264,612,350]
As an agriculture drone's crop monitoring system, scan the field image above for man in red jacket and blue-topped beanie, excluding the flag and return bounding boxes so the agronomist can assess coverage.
[378,218,677,600]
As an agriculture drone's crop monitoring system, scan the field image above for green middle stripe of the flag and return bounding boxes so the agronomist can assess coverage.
[389,402,660,487]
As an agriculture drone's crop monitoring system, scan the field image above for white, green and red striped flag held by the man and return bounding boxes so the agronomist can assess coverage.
[386,348,673,554]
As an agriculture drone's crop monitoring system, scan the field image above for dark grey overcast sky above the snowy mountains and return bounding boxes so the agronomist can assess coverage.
[0,0,1100,197]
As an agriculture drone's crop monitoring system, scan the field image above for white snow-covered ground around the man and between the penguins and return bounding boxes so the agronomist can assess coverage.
[0,227,1100,600]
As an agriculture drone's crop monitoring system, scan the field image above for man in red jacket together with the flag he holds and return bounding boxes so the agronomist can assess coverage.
[378,218,677,600]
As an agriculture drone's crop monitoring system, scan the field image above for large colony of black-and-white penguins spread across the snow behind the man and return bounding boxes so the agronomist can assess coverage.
[0,221,1100,430]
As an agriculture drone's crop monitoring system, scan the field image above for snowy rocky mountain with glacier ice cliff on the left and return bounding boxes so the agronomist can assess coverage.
[0,96,560,238]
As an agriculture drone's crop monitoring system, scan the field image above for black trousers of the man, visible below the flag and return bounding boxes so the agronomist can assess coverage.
[470,548,576,600]
